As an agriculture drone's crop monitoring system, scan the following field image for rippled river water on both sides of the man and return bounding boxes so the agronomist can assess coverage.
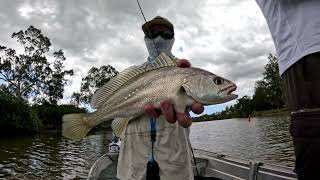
[0,117,294,179]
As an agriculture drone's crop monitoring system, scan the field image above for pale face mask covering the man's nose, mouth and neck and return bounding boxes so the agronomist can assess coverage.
[144,36,174,62]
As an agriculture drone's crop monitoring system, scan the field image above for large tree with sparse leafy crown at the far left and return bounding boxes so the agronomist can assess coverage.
[0,26,73,103]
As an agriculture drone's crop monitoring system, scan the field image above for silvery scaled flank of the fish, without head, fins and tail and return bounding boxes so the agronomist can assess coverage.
[91,67,216,123]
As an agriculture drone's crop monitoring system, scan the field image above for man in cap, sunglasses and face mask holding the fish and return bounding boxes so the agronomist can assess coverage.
[117,16,203,180]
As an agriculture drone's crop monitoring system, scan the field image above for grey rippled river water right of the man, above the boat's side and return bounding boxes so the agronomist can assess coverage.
[190,116,294,166]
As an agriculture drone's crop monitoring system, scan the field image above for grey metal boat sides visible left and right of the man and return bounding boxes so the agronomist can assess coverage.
[88,149,297,180]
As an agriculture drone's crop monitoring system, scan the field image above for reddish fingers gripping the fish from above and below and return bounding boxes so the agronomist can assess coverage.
[144,59,204,128]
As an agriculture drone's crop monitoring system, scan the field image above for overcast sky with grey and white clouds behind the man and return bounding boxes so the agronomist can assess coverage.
[0,0,275,113]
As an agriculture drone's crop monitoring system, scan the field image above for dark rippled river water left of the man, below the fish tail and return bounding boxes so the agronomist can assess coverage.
[0,132,112,179]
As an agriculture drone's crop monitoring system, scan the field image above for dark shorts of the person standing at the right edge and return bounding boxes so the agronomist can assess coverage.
[282,53,320,180]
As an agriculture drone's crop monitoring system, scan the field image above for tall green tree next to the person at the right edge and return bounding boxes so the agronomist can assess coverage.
[263,54,284,108]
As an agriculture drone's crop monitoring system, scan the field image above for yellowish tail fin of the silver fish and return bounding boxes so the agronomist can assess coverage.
[62,113,94,140]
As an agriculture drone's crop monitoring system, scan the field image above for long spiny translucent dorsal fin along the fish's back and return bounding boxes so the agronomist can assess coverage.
[90,53,176,108]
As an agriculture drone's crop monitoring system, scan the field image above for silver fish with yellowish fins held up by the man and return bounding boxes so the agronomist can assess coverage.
[62,53,237,140]
